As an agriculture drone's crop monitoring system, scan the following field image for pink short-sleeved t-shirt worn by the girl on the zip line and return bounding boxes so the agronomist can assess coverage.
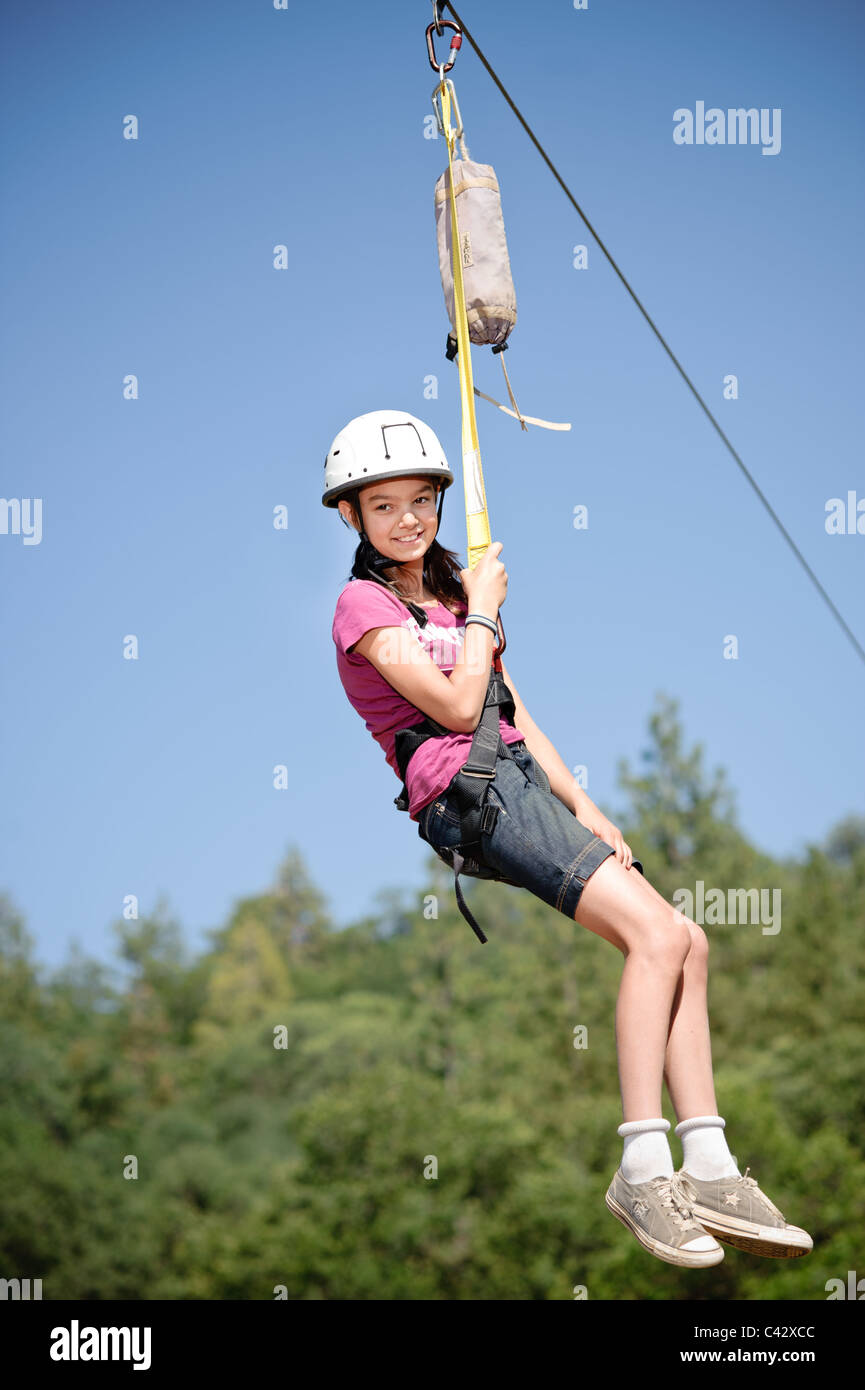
[332,578,523,820]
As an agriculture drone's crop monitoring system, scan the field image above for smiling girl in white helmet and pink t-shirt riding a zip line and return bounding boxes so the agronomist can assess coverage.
[321,410,812,1269]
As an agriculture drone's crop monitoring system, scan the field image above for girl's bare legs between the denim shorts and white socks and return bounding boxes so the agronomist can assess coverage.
[574,855,718,1120]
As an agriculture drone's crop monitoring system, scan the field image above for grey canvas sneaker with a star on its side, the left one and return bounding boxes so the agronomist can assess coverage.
[604,1168,723,1269]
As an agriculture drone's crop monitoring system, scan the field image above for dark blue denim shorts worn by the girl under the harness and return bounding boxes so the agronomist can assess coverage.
[417,741,615,920]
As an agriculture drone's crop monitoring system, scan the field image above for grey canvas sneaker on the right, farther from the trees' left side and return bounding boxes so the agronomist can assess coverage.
[677,1168,814,1259]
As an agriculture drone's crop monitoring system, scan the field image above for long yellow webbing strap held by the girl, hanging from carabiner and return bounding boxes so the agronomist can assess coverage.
[438,82,490,570]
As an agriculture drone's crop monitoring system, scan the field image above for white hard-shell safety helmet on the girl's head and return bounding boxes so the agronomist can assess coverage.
[321,410,453,507]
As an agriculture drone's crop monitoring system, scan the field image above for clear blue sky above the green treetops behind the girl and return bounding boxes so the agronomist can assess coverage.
[0,0,865,965]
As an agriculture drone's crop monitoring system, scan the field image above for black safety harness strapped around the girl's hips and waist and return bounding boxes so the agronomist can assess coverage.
[394,657,528,945]
